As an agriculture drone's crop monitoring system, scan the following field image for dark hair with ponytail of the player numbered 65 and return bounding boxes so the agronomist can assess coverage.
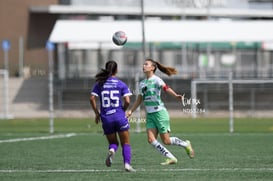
[95,60,118,85]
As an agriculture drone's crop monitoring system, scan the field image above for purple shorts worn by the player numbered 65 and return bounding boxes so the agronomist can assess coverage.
[101,114,130,135]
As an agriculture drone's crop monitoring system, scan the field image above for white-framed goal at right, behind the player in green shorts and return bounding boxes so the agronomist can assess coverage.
[191,74,273,132]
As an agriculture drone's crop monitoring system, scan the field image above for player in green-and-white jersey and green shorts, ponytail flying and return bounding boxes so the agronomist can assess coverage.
[126,59,194,165]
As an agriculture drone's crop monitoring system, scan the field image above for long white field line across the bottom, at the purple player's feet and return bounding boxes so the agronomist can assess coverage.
[0,168,273,173]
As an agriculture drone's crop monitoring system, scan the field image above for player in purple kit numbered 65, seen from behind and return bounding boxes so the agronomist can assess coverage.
[90,61,135,172]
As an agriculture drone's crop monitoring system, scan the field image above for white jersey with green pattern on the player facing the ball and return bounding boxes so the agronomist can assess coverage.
[139,75,165,113]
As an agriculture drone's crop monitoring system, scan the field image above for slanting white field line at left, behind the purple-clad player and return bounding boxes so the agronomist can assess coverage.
[0,133,76,143]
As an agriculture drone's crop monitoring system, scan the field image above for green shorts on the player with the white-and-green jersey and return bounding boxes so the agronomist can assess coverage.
[146,109,171,133]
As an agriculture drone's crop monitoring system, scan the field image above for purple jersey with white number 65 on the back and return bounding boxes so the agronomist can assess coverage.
[91,77,132,117]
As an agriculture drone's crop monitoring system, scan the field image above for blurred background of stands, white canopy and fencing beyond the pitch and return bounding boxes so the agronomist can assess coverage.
[0,0,273,119]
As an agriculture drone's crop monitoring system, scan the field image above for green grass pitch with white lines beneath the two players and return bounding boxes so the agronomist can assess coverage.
[0,118,273,181]
